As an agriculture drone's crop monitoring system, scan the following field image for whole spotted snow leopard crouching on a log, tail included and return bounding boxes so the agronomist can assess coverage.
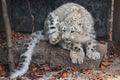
[8,3,100,79]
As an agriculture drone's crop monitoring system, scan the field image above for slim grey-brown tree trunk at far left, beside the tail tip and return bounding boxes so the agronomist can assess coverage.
[1,0,14,69]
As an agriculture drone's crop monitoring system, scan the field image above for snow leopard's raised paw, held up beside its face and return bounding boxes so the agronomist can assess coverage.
[49,32,61,45]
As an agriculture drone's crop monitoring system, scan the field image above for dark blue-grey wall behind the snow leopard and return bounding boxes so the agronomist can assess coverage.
[0,0,111,40]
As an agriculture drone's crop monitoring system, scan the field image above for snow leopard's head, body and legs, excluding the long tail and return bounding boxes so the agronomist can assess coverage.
[44,3,100,64]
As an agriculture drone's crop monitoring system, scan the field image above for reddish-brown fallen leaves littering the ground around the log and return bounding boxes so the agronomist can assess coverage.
[0,31,120,80]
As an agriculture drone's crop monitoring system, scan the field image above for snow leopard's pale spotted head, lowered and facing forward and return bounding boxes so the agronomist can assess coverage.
[60,22,83,43]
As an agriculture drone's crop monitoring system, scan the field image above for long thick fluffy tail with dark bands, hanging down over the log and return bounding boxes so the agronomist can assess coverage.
[8,31,45,79]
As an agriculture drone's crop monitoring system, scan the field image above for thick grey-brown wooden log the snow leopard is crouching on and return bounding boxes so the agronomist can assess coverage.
[32,42,107,70]
